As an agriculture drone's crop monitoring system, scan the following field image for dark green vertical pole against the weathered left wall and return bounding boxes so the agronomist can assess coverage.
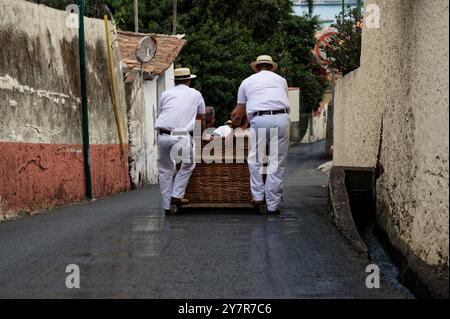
[78,0,92,199]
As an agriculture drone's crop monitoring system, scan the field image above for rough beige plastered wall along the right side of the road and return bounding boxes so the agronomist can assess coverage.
[334,0,449,276]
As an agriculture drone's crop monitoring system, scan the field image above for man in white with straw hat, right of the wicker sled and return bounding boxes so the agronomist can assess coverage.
[236,55,290,214]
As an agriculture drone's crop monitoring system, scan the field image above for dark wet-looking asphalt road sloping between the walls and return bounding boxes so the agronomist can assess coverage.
[0,143,405,298]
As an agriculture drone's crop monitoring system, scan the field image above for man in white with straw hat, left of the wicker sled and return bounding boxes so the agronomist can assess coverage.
[155,68,205,214]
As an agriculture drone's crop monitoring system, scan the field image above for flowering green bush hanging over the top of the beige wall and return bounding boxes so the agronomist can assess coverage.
[327,8,363,75]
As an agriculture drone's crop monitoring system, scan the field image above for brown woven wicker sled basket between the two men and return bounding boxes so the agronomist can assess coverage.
[185,137,252,208]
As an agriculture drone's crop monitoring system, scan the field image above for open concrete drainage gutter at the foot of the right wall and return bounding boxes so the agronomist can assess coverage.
[329,166,415,298]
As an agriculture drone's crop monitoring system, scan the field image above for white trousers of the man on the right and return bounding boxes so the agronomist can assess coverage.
[248,113,290,211]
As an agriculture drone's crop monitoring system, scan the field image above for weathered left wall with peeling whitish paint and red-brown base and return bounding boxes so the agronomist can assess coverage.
[0,0,129,219]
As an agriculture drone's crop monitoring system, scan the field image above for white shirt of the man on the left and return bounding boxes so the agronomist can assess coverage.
[155,84,206,132]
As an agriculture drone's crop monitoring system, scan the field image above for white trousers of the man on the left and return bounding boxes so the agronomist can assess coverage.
[157,134,195,210]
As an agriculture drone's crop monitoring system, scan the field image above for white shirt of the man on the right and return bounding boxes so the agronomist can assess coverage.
[238,70,289,117]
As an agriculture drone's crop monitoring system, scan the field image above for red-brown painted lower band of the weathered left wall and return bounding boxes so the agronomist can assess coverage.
[0,142,130,215]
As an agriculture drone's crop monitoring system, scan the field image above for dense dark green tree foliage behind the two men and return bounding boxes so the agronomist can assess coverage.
[107,0,327,123]
